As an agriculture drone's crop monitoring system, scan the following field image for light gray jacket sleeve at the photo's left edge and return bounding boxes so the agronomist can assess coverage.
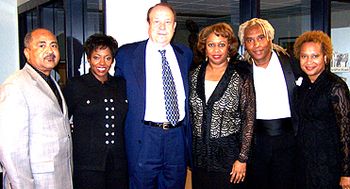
[0,83,35,189]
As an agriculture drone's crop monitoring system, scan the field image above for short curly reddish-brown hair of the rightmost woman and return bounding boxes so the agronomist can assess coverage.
[294,30,333,63]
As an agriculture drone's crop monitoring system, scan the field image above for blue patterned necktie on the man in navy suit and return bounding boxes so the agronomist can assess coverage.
[159,50,180,126]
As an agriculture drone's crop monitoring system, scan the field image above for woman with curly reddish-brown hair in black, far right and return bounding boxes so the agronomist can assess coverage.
[294,31,350,189]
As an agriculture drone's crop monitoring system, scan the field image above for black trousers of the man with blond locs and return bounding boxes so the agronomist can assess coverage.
[247,132,296,189]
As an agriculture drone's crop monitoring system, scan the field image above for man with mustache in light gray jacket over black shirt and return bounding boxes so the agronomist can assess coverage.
[0,28,73,189]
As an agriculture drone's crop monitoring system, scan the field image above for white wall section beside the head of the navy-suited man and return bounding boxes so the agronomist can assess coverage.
[106,0,160,46]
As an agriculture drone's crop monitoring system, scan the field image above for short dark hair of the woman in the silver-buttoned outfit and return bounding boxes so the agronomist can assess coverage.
[84,33,118,58]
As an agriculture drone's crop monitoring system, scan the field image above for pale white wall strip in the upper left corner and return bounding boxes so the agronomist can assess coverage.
[0,0,19,83]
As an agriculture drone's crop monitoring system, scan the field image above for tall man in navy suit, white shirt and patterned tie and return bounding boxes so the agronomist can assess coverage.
[115,3,193,189]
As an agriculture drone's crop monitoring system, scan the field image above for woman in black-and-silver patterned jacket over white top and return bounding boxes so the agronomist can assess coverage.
[190,23,255,189]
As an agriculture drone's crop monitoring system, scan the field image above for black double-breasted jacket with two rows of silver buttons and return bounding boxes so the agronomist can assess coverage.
[63,73,128,173]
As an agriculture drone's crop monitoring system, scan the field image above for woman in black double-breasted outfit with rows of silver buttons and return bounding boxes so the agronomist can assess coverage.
[64,34,128,189]
